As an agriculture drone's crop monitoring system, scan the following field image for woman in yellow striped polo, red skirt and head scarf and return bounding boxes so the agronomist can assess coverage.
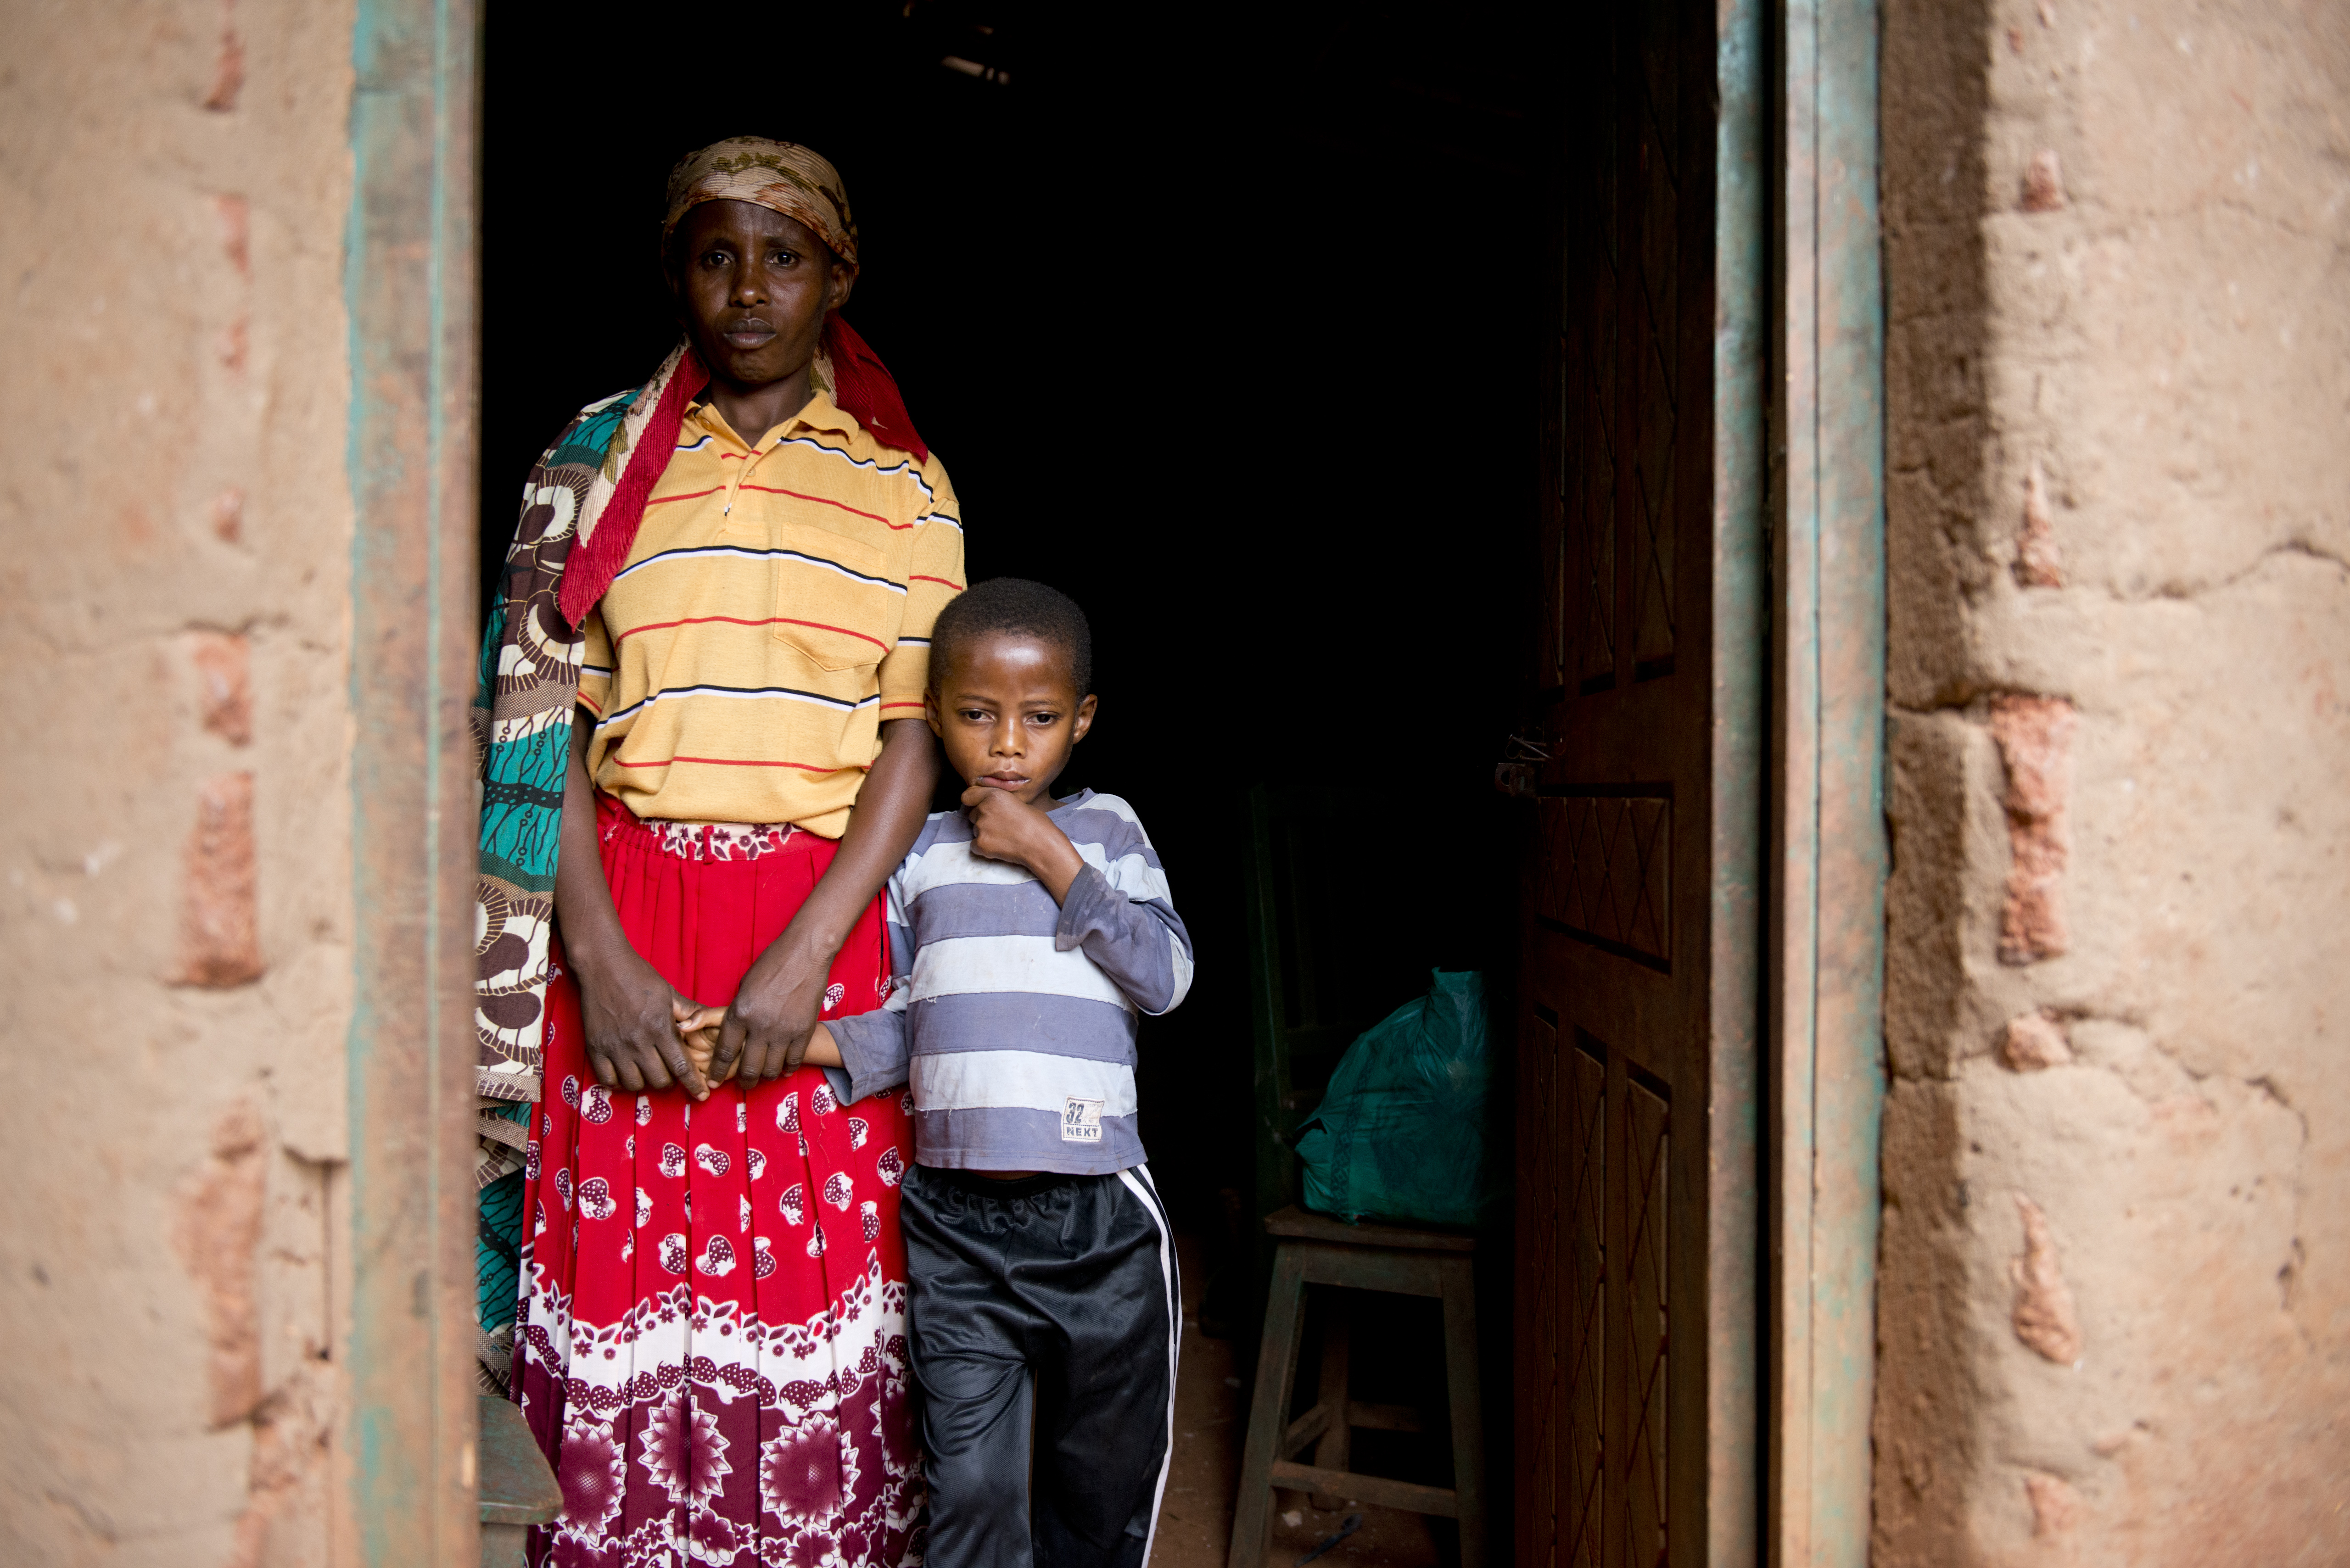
[479,139,963,1568]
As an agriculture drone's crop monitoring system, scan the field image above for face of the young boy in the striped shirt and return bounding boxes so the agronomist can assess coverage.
[923,632,1093,809]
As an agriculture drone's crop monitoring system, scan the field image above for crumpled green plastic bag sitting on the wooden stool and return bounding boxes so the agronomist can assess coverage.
[1297,969,1502,1227]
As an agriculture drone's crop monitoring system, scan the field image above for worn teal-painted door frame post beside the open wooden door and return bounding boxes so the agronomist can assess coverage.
[1765,0,1889,1568]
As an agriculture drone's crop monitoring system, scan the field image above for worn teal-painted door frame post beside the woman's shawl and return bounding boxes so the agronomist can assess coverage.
[336,0,479,1568]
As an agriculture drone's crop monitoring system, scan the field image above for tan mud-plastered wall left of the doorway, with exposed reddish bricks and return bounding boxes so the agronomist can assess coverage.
[0,0,352,1568]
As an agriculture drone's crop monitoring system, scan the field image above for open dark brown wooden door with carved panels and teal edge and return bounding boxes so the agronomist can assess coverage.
[1516,0,1765,1568]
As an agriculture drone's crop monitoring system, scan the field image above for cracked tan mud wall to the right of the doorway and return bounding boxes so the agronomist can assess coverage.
[1875,0,2350,1568]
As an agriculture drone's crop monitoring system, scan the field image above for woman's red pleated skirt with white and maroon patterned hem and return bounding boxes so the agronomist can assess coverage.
[515,802,921,1568]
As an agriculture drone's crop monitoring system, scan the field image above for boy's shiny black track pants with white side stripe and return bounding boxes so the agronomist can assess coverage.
[898,1166,1182,1568]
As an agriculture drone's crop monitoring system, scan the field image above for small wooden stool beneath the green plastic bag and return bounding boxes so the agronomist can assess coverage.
[1229,1206,1485,1568]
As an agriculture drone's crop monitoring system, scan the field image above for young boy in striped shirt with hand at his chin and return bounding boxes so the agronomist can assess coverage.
[686,578,1192,1568]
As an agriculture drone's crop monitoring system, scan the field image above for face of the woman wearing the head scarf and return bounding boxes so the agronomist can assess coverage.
[670,202,856,388]
